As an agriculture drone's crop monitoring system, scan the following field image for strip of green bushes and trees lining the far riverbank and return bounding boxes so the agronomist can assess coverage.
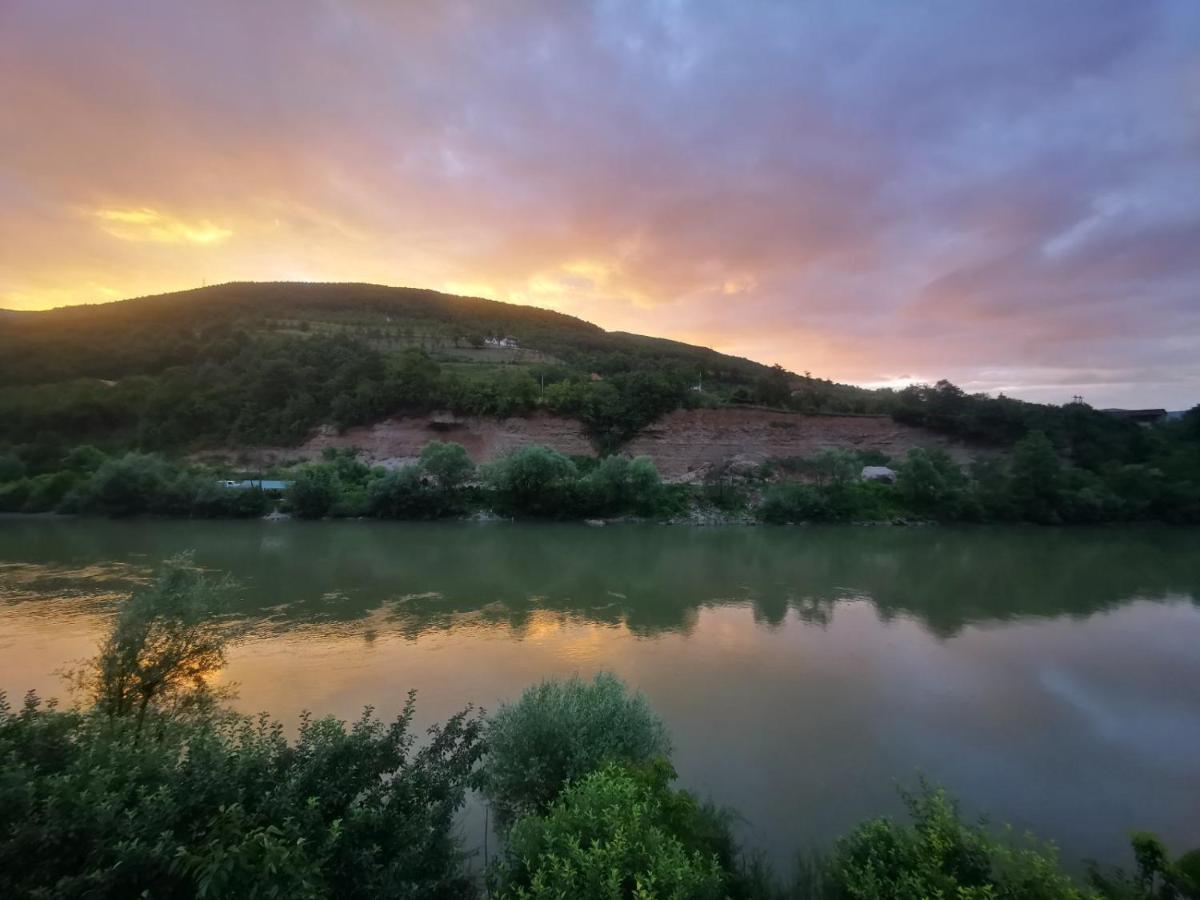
[0,427,1200,524]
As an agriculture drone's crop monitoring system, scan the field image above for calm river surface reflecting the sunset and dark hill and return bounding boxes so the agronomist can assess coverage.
[0,518,1200,865]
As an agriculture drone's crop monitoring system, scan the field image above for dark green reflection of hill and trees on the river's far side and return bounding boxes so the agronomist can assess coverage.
[0,521,1200,637]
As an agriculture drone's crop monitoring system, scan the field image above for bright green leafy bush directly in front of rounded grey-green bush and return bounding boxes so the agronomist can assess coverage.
[496,764,726,900]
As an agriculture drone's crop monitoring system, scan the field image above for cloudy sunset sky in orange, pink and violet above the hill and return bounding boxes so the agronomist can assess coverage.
[0,0,1200,409]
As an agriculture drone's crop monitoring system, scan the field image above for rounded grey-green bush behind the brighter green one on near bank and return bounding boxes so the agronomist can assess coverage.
[481,673,671,826]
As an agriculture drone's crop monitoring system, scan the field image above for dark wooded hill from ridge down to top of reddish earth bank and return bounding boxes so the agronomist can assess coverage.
[0,282,1176,468]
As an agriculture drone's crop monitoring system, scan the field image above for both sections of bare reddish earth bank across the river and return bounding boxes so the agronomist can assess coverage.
[220,408,972,481]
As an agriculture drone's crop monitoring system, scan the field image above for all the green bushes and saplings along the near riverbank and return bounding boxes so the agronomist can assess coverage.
[0,557,1200,900]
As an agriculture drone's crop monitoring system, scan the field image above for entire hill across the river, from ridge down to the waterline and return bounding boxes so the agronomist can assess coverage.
[0,284,1200,523]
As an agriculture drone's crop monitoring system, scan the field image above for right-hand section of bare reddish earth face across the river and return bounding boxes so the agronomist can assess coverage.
[625,408,973,481]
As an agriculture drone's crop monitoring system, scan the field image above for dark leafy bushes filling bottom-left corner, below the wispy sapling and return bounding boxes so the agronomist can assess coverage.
[0,697,481,898]
